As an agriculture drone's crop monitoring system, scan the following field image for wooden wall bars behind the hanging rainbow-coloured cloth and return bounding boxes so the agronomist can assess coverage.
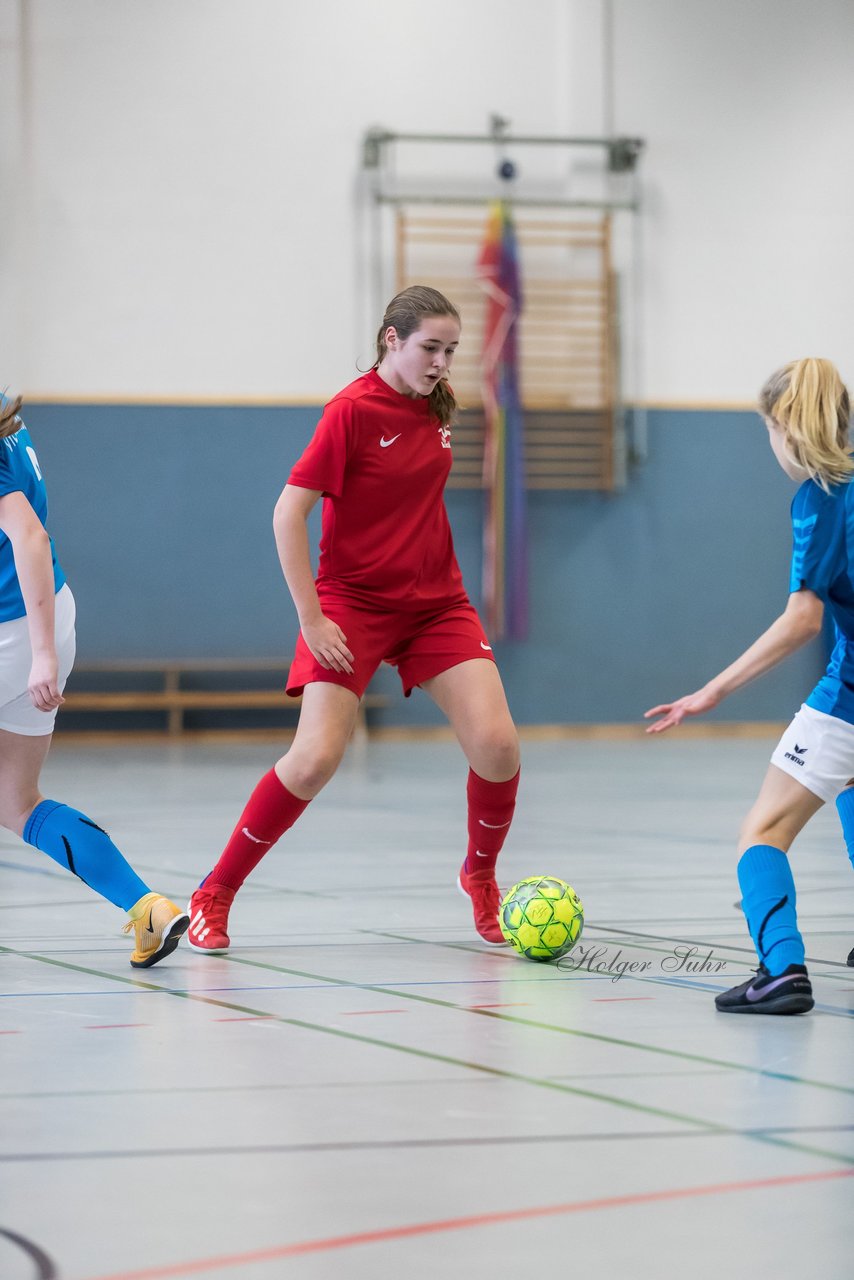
[396,207,618,490]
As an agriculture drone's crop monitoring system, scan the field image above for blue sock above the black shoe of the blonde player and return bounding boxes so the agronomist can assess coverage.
[739,845,804,977]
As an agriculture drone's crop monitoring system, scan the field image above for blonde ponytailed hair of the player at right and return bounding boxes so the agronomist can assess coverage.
[759,357,854,492]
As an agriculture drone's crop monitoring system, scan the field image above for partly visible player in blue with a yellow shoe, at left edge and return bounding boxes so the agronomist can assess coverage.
[0,396,189,969]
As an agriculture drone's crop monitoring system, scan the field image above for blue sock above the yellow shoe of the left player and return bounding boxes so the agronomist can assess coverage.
[24,800,150,911]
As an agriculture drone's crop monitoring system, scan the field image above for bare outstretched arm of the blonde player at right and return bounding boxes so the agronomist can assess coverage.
[644,588,825,733]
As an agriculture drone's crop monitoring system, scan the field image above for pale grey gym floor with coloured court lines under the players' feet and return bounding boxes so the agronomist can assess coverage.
[0,735,854,1280]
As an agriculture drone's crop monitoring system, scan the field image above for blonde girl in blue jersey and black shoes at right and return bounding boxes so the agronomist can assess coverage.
[647,360,854,1014]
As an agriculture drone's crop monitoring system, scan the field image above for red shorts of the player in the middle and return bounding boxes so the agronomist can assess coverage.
[287,599,495,698]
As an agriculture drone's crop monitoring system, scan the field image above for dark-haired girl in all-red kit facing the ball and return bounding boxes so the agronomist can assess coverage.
[188,285,520,952]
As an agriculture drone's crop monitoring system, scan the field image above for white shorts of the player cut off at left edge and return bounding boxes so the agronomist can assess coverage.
[0,584,77,737]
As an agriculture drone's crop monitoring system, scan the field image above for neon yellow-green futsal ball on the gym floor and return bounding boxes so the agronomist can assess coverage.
[498,876,584,960]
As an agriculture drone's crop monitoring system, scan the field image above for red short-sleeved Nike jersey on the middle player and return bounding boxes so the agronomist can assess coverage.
[288,370,467,611]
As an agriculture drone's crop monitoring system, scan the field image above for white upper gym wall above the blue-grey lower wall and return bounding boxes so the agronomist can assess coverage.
[0,0,854,402]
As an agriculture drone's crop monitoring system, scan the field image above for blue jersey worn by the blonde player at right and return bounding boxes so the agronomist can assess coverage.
[789,480,854,724]
